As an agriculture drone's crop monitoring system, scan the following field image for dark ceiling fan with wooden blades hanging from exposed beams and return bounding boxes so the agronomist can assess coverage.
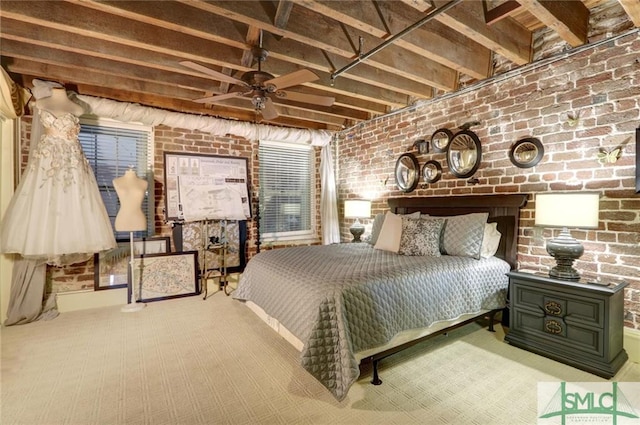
[180,37,335,120]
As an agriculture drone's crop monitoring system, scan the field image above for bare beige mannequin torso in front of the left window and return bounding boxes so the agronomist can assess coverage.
[113,170,148,232]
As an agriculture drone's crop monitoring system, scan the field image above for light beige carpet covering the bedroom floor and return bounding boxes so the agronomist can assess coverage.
[0,292,640,425]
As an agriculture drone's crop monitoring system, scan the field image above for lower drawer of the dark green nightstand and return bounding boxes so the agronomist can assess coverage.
[512,308,605,357]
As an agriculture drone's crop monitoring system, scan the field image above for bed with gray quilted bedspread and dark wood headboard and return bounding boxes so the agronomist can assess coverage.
[233,194,527,400]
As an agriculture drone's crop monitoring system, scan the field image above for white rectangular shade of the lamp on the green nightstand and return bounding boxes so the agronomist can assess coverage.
[535,192,600,229]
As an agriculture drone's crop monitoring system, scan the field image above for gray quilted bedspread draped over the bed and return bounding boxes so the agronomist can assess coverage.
[233,243,509,400]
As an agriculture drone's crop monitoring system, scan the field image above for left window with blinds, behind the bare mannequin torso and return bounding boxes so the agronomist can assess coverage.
[79,119,155,241]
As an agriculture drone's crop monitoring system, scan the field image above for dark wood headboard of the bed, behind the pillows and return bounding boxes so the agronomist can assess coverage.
[387,194,527,269]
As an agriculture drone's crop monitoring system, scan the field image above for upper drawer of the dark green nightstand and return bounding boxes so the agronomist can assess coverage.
[511,283,605,328]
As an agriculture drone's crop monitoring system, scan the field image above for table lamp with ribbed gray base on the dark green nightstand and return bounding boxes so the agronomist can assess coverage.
[535,192,600,280]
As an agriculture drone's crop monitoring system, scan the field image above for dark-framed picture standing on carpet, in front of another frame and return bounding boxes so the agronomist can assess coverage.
[127,251,200,302]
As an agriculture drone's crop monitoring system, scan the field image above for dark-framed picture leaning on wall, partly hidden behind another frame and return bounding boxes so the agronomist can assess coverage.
[93,236,171,291]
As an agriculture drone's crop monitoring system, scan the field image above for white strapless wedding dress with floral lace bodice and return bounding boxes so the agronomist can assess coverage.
[0,108,116,266]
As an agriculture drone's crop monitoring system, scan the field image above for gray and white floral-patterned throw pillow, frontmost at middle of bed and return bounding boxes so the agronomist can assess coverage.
[398,219,444,257]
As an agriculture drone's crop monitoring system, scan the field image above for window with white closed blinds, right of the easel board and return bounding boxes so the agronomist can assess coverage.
[259,141,315,241]
